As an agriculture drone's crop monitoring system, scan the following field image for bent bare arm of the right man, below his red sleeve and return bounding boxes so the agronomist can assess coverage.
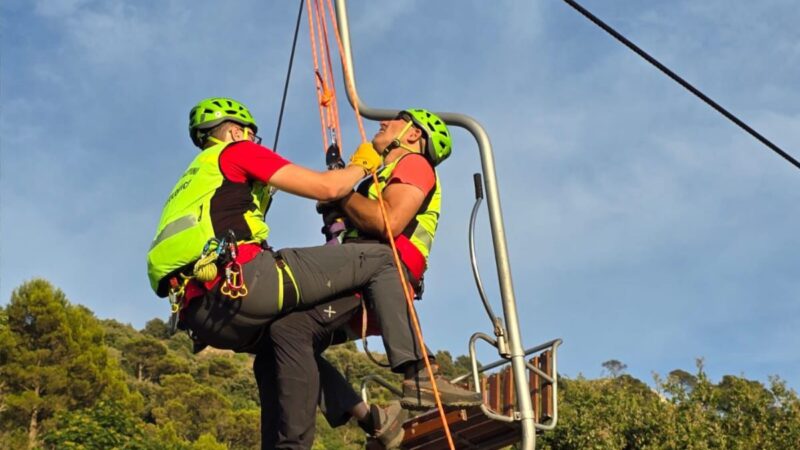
[341,183,425,237]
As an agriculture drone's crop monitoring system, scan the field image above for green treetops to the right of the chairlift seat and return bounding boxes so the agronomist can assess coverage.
[539,360,800,450]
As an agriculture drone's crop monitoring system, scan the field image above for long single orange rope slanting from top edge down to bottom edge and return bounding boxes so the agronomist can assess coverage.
[328,0,456,450]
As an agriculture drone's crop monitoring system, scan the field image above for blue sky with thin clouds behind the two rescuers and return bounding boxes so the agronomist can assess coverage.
[0,0,800,388]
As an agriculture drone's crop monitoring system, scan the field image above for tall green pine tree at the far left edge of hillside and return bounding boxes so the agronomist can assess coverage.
[0,279,140,448]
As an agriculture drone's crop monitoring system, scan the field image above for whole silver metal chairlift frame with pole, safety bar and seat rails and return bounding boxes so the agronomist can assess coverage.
[335,0,561,450]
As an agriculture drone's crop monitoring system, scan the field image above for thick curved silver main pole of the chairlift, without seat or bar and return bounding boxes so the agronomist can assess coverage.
[336,0,536,450]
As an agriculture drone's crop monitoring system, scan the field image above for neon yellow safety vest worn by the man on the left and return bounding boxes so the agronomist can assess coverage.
[147,144,269,296]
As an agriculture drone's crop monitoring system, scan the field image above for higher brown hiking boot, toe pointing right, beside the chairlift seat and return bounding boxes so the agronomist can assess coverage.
[400,375,483,410]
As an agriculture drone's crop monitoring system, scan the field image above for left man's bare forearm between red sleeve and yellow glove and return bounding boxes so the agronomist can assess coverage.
[269,164,364,201]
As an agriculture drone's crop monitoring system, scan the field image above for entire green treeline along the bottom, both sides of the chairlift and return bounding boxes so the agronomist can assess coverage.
[0,280,800,450]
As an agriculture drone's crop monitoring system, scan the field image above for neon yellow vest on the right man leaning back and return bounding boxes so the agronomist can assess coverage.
[345,153,442,279]
